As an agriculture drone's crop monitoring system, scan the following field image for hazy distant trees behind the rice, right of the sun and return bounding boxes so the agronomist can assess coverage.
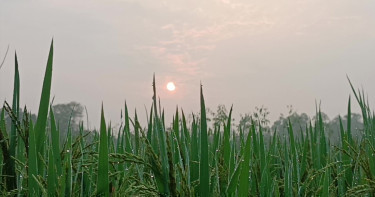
[207,105,363,143]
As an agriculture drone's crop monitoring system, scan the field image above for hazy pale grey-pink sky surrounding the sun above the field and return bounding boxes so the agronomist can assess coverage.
[0,0,375,127]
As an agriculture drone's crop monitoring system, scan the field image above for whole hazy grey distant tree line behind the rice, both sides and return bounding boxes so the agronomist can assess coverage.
[0,101,363,143]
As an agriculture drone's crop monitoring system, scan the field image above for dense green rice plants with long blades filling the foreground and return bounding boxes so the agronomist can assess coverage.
[0,41,375,196]
